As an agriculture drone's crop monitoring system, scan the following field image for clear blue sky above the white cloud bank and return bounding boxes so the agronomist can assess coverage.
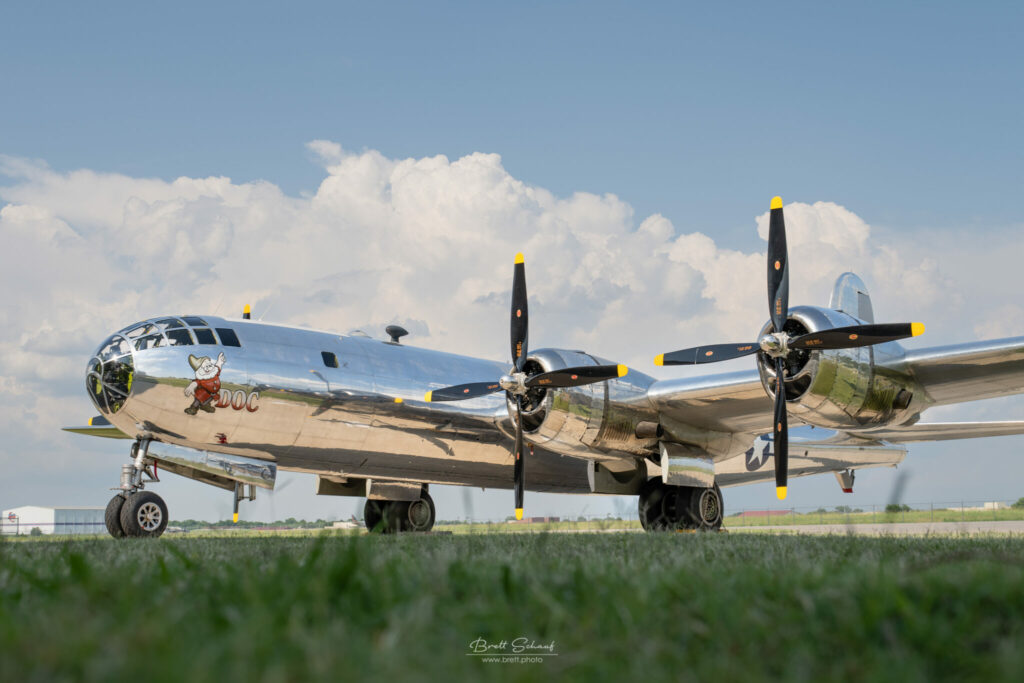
[0,2,1024,245]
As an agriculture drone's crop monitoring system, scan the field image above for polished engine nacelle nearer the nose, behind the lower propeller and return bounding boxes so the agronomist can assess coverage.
[509,349,657,460]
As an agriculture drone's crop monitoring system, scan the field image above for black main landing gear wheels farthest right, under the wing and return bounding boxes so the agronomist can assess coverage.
[639,477,724,531]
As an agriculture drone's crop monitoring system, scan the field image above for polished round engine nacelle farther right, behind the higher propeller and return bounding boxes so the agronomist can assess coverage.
[758,306,912,429]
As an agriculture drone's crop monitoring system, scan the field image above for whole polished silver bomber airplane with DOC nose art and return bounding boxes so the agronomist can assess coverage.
[68,198,1024,537]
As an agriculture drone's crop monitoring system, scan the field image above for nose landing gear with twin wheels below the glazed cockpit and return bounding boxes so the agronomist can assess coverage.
[103,441,168,539]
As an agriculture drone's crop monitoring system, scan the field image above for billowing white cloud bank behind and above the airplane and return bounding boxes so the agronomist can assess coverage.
[0,140,1024,516]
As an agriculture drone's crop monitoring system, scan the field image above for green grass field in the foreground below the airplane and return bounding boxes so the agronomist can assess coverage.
[0,533,1024,682]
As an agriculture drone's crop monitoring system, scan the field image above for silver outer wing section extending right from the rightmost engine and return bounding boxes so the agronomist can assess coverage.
[903,337,1024,405]
